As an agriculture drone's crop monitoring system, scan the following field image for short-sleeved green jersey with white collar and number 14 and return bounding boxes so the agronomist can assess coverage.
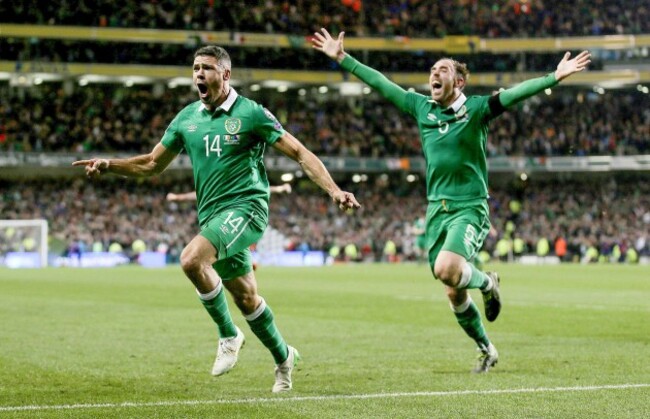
[161,88,284,227]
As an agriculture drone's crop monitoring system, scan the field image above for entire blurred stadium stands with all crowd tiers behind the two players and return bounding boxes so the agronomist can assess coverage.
[0,0,650,267]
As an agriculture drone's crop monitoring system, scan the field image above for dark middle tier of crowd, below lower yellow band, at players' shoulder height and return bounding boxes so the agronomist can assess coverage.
[0,83,650,157]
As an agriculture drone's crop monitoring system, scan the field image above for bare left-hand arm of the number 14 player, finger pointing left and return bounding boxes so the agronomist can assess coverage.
[72,143,177,178]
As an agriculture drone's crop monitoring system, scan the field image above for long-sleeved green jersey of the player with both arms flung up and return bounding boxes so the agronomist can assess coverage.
[341,55,557,202]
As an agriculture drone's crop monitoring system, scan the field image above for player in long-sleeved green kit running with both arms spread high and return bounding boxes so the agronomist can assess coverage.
[312,29,591,373]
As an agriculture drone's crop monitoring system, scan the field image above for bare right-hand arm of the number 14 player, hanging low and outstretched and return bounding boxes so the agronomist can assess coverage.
[273,131,361,210]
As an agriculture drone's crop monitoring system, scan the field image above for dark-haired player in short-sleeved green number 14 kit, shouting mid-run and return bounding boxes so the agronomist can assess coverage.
[73,46,360,393]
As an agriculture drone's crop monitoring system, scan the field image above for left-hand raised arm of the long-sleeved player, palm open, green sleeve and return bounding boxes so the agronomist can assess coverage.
[311,28,407,111]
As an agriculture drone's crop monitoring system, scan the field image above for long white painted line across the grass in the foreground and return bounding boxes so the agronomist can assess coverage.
[0,383,650,412]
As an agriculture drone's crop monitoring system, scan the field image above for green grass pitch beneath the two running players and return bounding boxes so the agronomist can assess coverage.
[0,264,650,418]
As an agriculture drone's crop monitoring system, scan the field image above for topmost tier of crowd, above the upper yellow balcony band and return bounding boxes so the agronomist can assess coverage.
[0,0,650,38]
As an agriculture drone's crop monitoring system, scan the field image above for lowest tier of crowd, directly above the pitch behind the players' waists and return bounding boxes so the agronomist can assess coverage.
[0,175,650,262]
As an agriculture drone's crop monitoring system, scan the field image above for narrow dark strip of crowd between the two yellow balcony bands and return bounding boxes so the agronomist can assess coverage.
[0,37,592,73]
